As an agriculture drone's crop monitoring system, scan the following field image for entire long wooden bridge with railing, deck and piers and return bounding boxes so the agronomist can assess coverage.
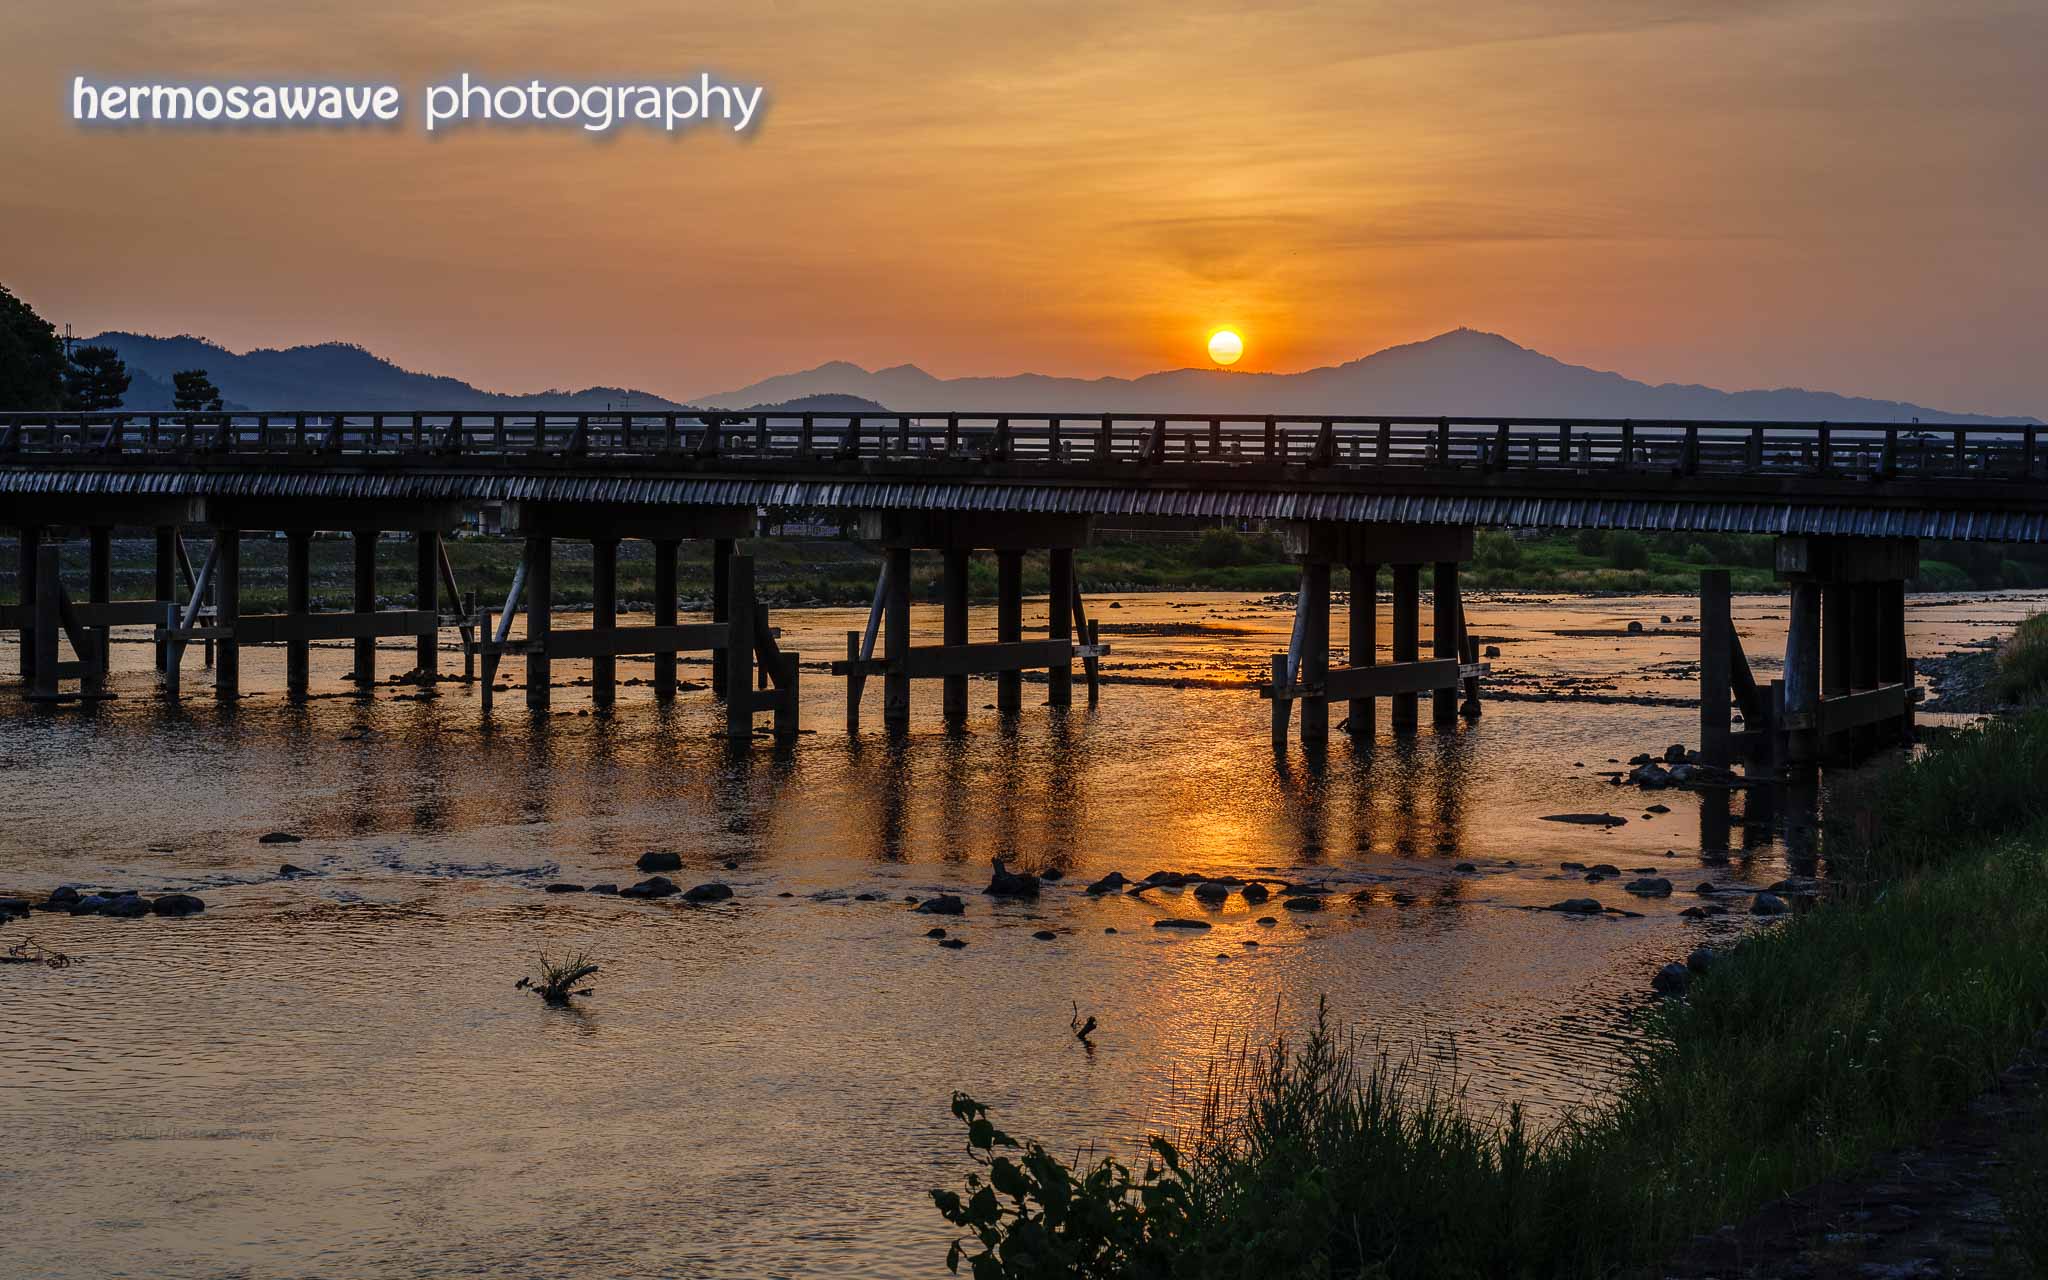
[0,412,2048,762]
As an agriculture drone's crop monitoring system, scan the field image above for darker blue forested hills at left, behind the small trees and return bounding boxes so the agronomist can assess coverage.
[86,332,684,412]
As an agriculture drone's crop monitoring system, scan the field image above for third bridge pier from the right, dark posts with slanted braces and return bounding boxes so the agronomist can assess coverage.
[831,510,1106,733]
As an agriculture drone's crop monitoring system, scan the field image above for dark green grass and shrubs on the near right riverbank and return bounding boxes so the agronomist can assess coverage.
[937,713,2048,1278]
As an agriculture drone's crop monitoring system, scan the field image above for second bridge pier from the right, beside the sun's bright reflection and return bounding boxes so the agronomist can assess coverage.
[1260,522,1485,748]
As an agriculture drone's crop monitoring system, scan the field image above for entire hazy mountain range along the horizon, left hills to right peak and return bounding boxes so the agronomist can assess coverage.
[88,328,2038,424]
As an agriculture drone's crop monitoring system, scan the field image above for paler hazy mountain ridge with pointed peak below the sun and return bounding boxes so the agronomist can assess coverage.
[696,330,2032,424]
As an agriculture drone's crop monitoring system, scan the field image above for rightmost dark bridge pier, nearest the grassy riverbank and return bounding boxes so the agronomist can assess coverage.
[1700,535,1921,772]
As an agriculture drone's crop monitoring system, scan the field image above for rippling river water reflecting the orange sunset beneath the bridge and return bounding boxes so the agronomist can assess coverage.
[0,594,2042,1278]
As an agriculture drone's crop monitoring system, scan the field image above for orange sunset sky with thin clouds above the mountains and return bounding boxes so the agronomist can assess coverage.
[0,0,2048,414]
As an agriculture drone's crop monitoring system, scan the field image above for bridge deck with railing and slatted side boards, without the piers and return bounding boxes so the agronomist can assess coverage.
[0,412,2048,543]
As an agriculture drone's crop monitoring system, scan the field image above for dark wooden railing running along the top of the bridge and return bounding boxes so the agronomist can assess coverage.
[0,410,2044,481]
